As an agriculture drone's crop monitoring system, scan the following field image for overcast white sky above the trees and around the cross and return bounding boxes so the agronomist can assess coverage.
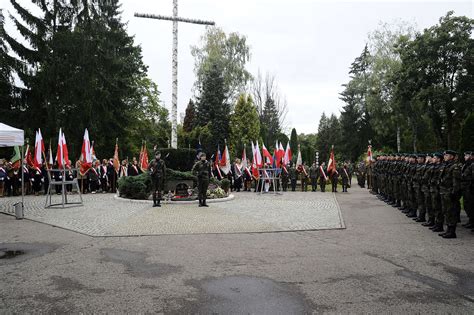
[0,0,474,133]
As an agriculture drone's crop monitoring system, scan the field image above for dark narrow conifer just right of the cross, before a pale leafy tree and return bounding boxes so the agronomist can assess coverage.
[196,64,230,151]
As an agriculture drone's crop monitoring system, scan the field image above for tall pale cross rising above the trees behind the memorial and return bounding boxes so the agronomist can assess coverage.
[135,0,215,149]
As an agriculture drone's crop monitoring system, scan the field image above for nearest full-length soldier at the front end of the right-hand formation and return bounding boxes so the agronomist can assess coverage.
[433,150,461,238]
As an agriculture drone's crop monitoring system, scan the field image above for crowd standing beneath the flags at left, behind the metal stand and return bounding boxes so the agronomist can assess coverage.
[0,158,143,197]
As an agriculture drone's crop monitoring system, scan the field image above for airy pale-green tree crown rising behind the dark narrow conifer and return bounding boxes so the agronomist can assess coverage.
[191,27,252,104]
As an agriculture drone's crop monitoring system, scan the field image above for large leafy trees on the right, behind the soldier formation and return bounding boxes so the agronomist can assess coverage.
[336,12,474,159]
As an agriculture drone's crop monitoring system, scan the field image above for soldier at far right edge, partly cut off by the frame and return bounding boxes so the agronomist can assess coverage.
[461,151,474,229]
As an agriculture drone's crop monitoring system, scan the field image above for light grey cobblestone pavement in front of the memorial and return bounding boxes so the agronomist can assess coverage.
[0,192,344,236]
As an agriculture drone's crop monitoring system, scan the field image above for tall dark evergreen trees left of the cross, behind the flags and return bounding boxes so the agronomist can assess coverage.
[3,0,170,157]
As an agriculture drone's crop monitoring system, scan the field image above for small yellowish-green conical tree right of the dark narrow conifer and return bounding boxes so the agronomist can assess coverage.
[229,94,260,157]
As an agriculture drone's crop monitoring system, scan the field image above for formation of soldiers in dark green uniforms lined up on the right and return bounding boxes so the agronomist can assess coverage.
[357,150,474,238]
